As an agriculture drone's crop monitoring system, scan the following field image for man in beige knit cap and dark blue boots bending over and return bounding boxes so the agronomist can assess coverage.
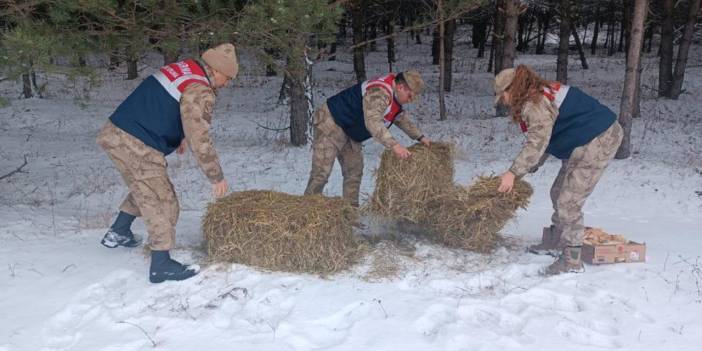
[97,44,239,283]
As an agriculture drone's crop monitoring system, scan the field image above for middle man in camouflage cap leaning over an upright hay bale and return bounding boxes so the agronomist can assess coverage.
[305,70,431,206]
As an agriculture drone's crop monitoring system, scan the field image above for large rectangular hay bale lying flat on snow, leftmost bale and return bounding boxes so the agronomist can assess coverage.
[202,190,362,274]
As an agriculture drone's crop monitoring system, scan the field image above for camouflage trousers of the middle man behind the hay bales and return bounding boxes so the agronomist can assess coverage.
[305,103,363,206]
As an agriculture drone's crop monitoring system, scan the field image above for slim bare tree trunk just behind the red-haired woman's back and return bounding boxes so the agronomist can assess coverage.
[615,0,652,159]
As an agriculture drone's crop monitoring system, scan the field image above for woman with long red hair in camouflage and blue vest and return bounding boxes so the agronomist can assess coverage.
[495,65,623,275]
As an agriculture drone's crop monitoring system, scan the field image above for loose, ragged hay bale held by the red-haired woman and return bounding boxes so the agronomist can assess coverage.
[422,177,533,253]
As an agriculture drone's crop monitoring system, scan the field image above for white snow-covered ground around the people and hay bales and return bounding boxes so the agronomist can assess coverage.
[0,31,702,351]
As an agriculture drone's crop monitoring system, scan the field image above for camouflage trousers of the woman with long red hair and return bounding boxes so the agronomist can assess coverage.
[551,121,624,246]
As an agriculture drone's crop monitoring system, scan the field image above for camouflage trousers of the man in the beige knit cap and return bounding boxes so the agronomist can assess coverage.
[97,121,180,250]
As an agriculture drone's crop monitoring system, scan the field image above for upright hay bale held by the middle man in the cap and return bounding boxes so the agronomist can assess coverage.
[366,142,454,223]
